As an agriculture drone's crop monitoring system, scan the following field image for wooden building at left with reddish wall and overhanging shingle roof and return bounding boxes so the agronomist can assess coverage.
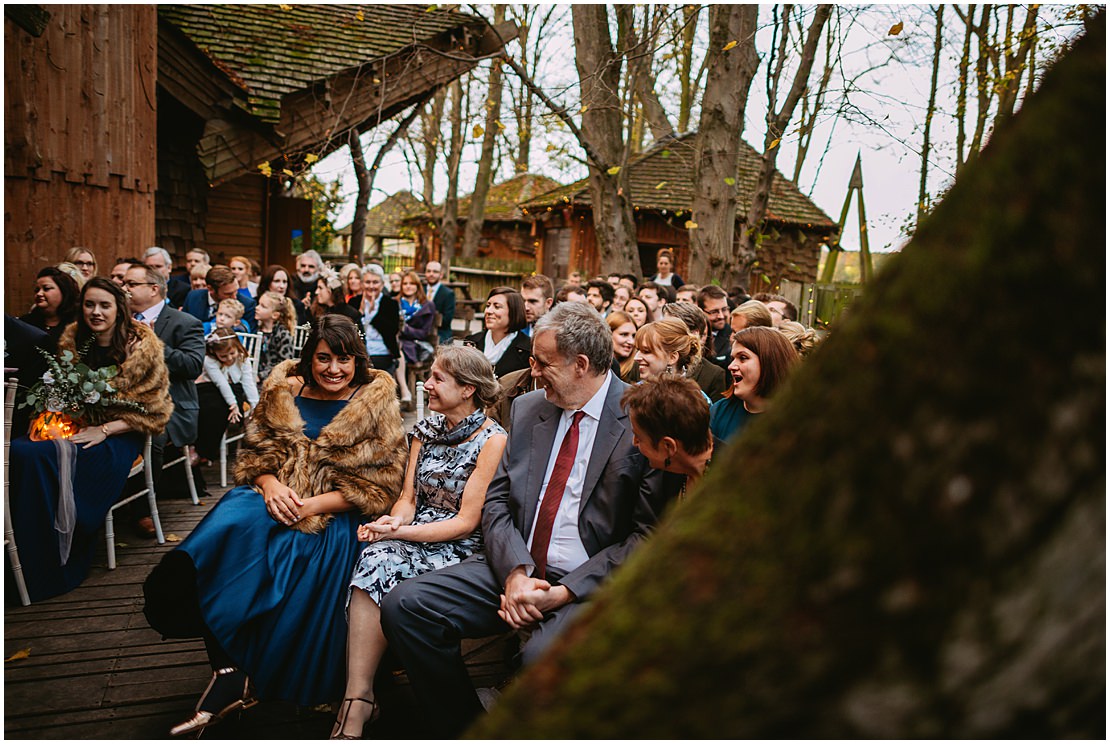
[4,4,516,312]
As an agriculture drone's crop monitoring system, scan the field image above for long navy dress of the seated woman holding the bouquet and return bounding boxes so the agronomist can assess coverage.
[4,432,144,603]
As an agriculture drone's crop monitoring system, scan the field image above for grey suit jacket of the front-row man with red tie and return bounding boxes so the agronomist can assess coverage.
[482,378,680,601]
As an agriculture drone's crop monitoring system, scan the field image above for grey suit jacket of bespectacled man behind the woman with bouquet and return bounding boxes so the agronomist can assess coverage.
[154,306,208,446]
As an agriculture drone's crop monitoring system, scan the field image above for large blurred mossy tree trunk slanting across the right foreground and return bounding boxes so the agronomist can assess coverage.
[472,16,1106,738]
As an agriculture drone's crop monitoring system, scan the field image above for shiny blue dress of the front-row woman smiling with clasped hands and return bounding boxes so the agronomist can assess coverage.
[147,396,361,705]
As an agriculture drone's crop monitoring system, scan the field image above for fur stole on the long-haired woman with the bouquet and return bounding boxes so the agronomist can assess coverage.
[58,323,173,435]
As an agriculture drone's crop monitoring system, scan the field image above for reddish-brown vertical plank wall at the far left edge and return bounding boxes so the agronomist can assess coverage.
[4,4,158,313]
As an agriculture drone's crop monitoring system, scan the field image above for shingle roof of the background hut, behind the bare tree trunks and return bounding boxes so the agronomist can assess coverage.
[521,132,836,229]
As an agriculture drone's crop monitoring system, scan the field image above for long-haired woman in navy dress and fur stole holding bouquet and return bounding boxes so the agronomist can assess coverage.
[8,277,173,602]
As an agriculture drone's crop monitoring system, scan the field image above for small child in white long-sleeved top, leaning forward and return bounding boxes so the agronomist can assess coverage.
[193,333,259,461]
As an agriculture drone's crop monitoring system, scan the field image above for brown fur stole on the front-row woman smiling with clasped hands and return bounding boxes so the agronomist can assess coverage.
[235,359,407,532]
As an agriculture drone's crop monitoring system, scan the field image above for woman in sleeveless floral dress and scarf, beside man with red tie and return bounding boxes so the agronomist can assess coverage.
[332,346,506,738]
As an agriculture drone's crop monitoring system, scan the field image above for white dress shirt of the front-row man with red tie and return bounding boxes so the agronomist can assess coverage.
[526,372,613,576]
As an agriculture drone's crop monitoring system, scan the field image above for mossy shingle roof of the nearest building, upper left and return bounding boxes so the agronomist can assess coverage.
[158,4,475,123]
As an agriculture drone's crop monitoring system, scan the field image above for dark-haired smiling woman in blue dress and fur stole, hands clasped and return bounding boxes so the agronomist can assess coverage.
[144,314,405,734]
